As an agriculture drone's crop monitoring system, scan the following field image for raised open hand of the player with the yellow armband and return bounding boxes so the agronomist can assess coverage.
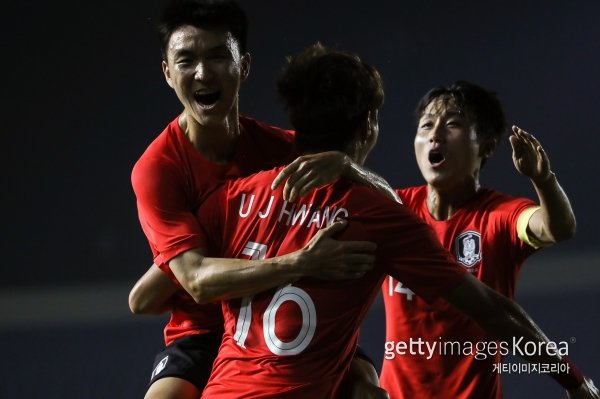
[509,126,553,184]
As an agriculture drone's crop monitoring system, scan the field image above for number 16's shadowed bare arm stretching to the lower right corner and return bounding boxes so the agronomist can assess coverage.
[444,273,600,398]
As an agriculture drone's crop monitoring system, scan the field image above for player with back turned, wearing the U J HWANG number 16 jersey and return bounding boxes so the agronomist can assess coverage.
[171,44,598,399]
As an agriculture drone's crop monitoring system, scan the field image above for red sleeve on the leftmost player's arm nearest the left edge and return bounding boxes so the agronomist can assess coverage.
[131,158,205,271]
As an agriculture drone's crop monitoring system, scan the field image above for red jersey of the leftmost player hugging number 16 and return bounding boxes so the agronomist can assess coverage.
[131,116,293,345]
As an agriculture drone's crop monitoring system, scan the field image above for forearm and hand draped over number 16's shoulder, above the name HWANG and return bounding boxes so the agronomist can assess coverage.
[271,151,401,202]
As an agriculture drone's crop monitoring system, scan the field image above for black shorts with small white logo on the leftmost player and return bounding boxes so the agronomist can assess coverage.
[149,333,223,391]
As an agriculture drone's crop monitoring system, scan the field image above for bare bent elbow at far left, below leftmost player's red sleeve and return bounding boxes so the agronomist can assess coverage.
[129,265,179,315]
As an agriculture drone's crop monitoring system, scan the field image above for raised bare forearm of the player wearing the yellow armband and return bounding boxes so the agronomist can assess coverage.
[530,173,576,243]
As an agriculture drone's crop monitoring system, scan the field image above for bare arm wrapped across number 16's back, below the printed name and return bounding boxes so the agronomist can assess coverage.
[169,222,375,303]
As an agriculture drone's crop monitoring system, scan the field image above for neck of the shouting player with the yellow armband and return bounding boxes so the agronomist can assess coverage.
[427,179,480,220]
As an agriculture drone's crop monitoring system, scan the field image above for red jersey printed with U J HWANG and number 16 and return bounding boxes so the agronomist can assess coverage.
[198,168,466,399]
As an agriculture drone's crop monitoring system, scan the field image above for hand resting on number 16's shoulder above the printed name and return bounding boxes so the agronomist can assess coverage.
[271,151,351,201]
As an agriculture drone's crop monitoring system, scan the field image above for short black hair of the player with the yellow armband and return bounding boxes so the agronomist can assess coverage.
[415,80,508,161]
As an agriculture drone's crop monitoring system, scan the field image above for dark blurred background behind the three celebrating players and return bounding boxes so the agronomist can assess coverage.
[0,0,600,398]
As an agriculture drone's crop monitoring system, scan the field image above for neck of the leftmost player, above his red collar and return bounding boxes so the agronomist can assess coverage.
[179,113,240,163]
